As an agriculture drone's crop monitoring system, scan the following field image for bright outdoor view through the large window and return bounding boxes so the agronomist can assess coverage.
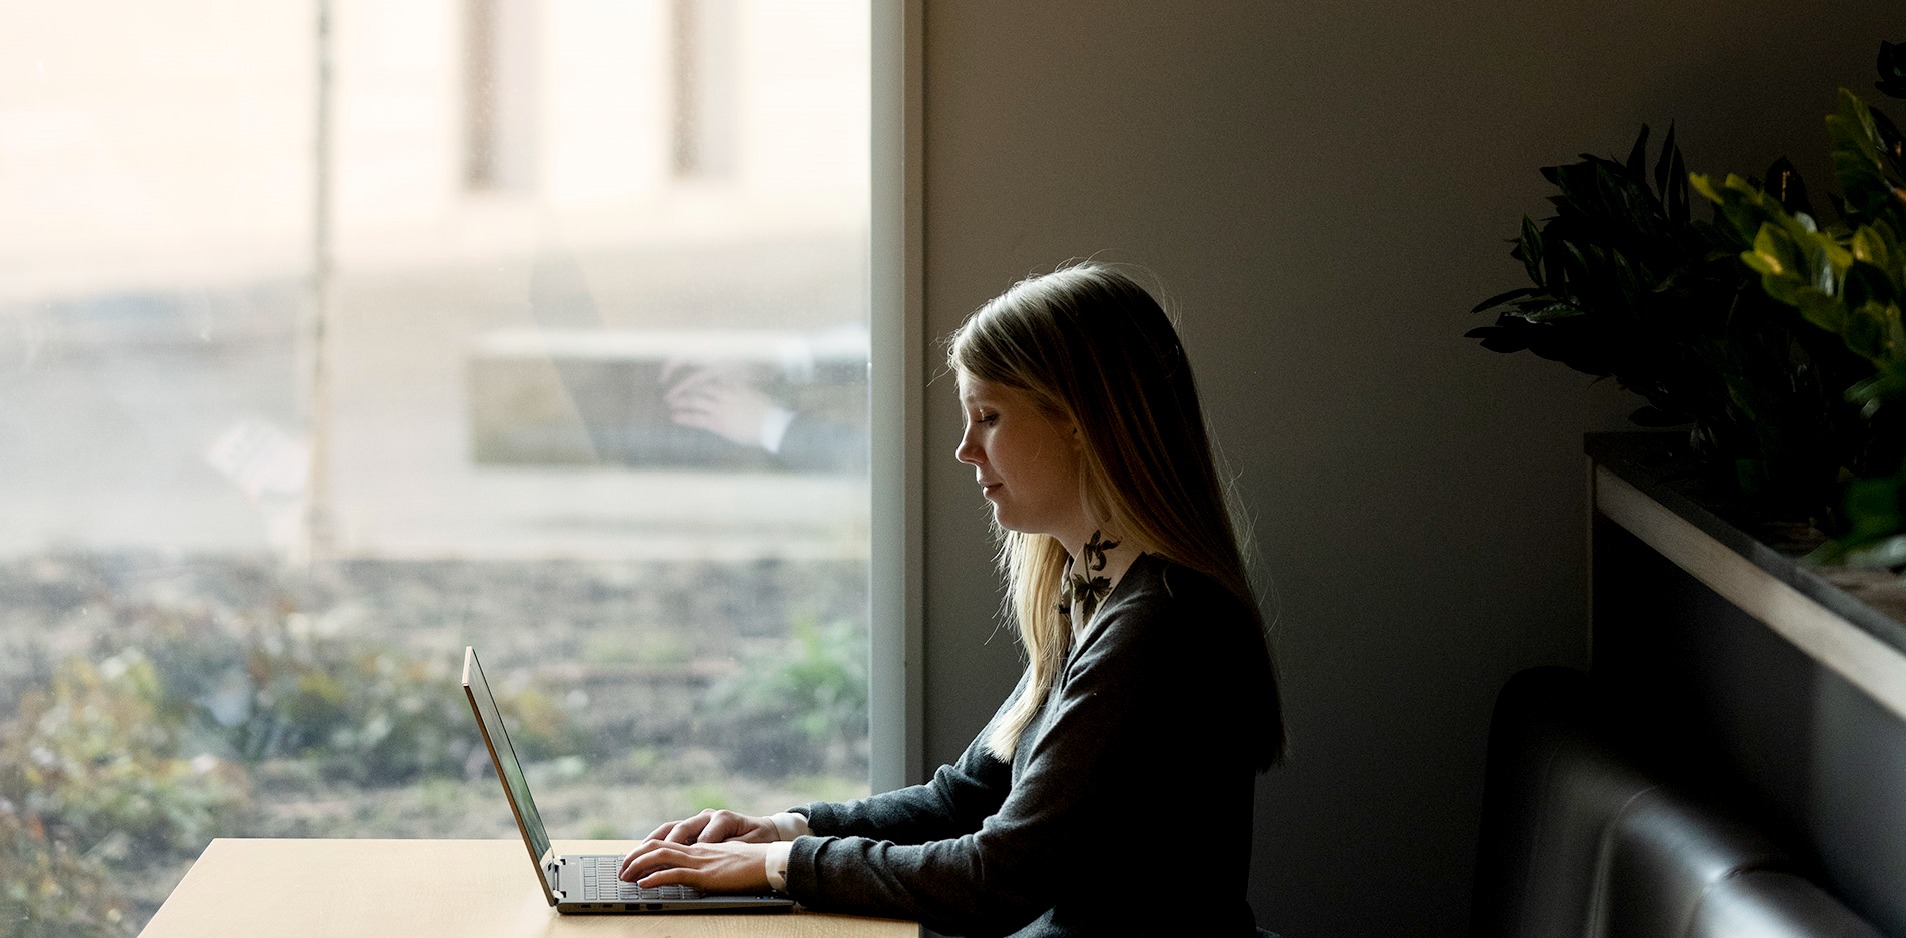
[0,0,869,936]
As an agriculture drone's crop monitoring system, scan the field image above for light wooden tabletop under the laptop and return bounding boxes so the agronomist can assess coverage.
[141,837,919,938]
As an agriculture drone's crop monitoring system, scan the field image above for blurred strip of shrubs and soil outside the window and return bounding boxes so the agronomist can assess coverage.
[0,555,867,936]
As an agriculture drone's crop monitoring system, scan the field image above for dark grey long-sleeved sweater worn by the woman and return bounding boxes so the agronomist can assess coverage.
[787,555,1275,938]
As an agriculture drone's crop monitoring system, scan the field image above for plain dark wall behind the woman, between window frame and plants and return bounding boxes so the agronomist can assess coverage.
[923,0,1906,938]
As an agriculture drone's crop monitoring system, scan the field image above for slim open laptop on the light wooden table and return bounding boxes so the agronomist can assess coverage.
[463,646,795,915]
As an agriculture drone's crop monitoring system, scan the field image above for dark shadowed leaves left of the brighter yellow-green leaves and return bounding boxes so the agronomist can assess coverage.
[1468,128,1864,526]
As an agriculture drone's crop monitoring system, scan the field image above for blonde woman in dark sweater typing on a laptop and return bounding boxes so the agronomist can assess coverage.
[621,263,1285,936]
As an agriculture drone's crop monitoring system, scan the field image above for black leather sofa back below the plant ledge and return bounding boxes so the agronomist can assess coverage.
[1471,667,1879,938]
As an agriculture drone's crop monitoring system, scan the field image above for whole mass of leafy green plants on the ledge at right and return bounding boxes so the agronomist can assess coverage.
[1468,44,1906,561]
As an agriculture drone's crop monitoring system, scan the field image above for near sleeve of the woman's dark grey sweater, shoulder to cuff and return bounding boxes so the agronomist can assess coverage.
[787,591,1199,934]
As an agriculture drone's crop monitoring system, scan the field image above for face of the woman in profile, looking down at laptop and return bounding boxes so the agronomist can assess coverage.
[953,374,1090,549]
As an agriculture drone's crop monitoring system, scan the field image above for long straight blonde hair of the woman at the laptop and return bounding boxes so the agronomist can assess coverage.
[947,261,1285,768]
